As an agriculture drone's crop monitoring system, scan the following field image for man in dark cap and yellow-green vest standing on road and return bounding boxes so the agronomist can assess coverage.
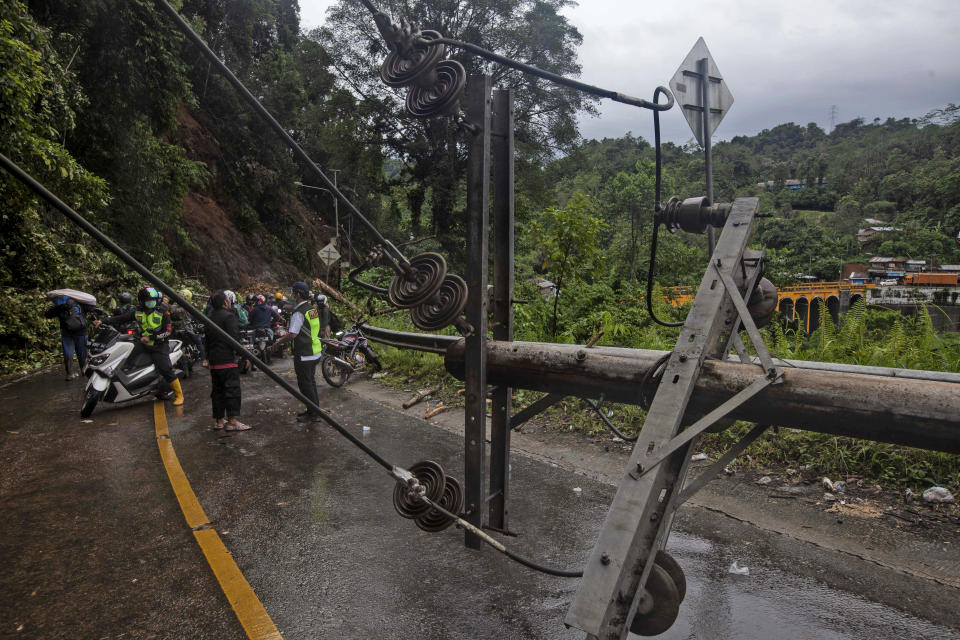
[273,282,330,422]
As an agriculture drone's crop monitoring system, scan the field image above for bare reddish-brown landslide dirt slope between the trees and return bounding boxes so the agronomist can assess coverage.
[168,105,333,288]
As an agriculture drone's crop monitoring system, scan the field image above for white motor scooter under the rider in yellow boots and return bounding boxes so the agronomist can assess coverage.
[80,325,183,418]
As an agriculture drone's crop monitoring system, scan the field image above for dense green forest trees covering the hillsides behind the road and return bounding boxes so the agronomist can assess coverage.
[0,0,960,370]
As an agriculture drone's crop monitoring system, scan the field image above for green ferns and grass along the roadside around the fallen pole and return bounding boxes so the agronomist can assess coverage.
[366,294,960,492]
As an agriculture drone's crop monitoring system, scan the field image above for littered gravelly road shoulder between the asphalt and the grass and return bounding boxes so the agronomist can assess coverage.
[345,378,960,628]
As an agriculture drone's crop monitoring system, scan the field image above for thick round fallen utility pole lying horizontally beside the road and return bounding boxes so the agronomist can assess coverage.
[446,340,960,453]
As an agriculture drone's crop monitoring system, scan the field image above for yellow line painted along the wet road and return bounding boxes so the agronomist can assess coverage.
[153,401,283,640]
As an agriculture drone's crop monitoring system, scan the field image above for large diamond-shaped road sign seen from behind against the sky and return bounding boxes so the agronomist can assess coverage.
[670,38,733,145]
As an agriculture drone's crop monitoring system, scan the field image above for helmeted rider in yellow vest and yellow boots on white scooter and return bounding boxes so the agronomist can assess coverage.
[93,287,183,405]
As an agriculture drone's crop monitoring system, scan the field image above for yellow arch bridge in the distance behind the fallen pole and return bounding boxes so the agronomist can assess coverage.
[663,282,877,333]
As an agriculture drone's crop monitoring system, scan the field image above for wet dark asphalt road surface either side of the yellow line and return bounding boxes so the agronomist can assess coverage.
[0,360,960,640]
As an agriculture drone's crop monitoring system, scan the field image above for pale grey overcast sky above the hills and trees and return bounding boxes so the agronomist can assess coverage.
[300,0,960,143]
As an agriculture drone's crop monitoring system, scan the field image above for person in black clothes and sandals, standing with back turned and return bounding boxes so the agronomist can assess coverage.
[204,293,251,431]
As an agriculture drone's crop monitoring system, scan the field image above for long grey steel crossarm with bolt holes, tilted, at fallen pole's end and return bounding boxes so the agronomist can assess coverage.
[565,198,769,640]
